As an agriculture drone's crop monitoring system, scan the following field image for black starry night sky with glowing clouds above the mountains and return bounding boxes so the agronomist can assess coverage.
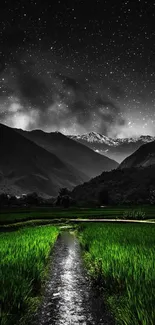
[0,0,155,137]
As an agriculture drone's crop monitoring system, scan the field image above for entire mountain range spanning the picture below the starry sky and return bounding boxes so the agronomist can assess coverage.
[0,124,155,199]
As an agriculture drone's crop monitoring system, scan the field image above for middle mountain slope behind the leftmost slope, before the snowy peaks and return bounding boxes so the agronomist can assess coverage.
[16,130,118,180]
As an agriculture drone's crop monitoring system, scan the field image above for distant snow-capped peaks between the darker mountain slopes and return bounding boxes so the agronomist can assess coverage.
[69,132,155,163]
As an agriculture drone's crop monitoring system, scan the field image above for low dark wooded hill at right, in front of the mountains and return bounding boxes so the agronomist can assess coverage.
[72,166,155,205]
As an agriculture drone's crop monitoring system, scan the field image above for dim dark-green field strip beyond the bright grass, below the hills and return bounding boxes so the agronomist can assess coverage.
[0,206,155,225]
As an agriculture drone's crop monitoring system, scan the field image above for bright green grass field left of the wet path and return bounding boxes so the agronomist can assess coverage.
[0,226,59,325]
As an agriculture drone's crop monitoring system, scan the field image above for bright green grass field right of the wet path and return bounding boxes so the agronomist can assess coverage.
[79,224,155,325]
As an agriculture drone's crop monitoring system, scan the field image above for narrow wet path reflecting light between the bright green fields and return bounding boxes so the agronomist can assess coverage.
[36,232,114,325]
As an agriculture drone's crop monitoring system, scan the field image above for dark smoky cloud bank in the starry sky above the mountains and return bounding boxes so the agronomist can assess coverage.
[1,58,125,135]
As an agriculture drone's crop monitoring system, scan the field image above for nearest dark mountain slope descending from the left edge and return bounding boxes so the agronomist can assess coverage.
[0,124,83,195]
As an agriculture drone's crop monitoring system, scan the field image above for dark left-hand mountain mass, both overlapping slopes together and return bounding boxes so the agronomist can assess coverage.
[0,124,118,196]
